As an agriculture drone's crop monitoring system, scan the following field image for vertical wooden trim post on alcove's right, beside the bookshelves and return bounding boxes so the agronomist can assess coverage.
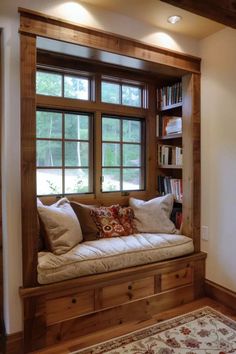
[182,74,201,252]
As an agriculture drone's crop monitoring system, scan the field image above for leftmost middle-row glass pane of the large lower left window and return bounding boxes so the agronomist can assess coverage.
[37,140,62,167]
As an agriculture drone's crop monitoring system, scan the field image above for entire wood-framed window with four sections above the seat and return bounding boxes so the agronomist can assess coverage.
[36,66,147,196]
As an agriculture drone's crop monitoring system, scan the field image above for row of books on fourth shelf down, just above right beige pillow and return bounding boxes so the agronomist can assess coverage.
[157,175,183,202]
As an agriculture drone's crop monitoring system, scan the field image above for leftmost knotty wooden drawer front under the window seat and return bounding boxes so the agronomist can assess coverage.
[46,290,94,325]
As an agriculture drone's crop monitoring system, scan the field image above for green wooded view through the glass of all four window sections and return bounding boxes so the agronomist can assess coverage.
[36,70,144,195]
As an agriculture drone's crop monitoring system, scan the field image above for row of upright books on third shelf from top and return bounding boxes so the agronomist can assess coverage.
[158,144,183,166]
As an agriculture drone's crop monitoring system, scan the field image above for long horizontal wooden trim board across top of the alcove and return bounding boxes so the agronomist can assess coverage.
[18,8,200,73]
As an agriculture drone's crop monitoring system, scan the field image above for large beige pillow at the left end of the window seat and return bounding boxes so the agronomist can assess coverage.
[37,198,83,254]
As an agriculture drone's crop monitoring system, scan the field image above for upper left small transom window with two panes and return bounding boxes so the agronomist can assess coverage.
[36,70,91,100]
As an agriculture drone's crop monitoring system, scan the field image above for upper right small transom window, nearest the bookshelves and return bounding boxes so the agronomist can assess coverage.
[102,81,143,107]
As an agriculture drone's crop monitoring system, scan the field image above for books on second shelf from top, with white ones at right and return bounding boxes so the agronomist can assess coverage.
[156,115,182,137]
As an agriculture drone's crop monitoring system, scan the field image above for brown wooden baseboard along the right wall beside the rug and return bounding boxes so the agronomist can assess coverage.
[205,279,236,311]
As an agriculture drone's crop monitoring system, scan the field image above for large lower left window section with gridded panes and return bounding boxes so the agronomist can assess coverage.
[36,110,92,195]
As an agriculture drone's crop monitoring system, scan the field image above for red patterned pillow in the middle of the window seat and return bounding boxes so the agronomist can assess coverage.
[91,205,126,238]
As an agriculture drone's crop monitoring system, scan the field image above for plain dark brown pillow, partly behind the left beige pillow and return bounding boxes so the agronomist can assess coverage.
[70,201,99,241]
